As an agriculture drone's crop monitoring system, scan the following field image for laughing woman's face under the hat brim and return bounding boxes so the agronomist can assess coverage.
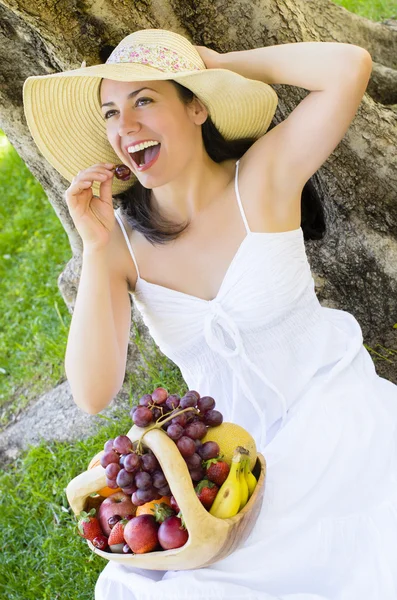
[100,79,208,188]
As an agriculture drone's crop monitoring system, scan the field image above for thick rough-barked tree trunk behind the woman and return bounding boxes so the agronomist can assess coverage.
[0,0,397,382]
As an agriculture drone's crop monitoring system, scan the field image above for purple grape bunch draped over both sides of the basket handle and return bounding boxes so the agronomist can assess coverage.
[101,388,223,506]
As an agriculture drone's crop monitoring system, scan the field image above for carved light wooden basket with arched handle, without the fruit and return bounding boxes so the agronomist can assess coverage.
[66,425,266,571]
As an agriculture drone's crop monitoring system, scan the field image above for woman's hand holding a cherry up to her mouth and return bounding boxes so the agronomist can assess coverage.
[65,163,115,249]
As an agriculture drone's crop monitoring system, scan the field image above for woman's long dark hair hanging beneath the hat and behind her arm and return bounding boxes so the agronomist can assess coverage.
[99,46,326,245]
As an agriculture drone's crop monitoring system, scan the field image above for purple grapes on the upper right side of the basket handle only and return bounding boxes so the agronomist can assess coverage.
[131,388,223,481]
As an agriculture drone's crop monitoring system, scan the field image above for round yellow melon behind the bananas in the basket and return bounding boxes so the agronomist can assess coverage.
[201,423,257,471]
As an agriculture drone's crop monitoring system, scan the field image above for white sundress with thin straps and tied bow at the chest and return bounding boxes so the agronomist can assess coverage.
[95,162,397,600]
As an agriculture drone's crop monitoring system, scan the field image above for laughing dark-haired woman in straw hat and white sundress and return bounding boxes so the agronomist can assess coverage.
[24,30,397,600]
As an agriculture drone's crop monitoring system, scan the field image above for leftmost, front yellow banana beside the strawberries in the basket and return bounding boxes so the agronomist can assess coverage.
[210,447,242,519]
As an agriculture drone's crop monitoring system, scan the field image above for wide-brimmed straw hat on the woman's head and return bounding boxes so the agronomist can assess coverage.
[23,29,277,195]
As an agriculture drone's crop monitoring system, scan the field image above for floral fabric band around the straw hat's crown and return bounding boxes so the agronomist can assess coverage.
[106,44,202,73]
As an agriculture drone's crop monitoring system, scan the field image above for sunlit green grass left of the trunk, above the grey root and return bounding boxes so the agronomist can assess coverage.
[0,132,71,425]
